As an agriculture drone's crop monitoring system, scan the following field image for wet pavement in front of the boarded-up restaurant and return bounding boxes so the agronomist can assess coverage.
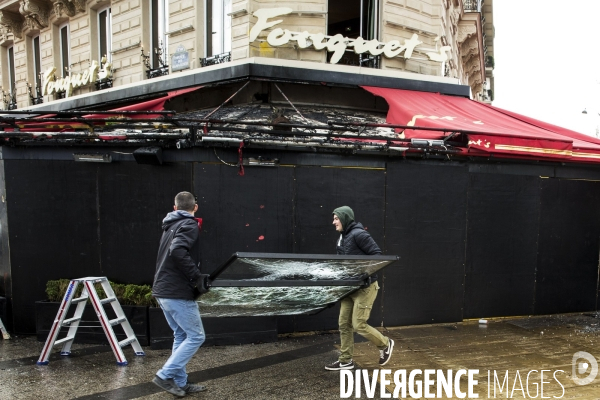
[0,314,600,400]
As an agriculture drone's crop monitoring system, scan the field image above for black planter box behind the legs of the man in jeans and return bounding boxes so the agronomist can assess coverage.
[148,307,277,350]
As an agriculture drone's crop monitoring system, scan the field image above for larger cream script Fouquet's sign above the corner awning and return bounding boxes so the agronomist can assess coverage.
[250,7,450,64]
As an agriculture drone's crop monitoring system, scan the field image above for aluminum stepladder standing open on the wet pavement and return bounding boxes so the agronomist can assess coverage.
[37,277,145,365]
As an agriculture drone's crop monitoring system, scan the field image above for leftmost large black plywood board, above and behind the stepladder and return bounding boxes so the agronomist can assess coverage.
[4,160,105,333]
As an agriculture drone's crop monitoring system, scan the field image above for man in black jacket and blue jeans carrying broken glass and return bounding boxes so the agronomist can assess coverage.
[152,192,206,397]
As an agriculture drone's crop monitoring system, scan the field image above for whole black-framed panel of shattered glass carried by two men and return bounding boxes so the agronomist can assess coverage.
[198,253,398,317]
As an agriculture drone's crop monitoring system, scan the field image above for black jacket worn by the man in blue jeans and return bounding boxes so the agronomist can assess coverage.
[152,211,200,300]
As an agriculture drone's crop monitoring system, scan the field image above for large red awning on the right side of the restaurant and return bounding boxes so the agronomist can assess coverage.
[363,86,600,162]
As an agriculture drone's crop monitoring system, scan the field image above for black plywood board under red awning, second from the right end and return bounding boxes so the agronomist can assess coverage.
[464,173,541,318]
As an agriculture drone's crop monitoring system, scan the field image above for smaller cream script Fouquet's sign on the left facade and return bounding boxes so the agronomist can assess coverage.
[42,60,112,97]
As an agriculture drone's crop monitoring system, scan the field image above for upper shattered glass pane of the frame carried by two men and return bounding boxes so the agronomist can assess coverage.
[214,257,393,281]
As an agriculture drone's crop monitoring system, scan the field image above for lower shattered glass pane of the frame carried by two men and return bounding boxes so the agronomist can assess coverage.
[197,286,358,317]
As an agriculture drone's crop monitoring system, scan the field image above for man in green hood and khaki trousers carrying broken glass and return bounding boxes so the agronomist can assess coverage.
[325,206,394,371]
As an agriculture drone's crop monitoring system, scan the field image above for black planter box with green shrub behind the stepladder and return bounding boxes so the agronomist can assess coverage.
[35,301,150,346]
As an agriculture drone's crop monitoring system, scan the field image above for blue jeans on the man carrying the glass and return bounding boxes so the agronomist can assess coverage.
[156,298,205,387]
